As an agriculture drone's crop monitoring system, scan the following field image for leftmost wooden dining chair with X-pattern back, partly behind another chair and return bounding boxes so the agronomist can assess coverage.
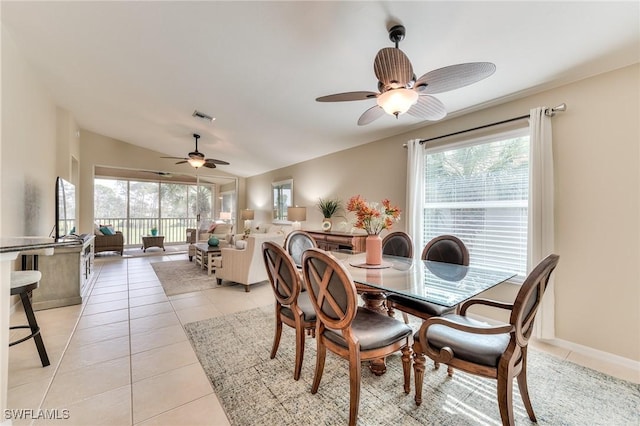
[262,241,316,380]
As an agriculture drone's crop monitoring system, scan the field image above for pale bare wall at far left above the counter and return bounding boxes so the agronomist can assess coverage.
[0,27,56,236]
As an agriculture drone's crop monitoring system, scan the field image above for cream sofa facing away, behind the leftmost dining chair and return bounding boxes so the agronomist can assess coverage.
[213,232,285,292]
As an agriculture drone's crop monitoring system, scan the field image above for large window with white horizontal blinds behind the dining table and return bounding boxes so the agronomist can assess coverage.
[424,129,529,278]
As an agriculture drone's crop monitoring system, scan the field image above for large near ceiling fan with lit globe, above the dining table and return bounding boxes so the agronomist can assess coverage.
[316,25,496,126]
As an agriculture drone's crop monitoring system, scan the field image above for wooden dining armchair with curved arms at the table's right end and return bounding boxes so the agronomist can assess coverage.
[413,254,560,425]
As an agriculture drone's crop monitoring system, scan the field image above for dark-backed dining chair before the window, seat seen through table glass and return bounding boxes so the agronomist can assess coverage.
[387,235,469,324]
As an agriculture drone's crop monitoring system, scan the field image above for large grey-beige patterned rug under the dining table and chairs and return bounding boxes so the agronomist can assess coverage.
[185,306,640,426]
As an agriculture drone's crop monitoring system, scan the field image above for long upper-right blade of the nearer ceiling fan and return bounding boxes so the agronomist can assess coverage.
[414,62,496,94]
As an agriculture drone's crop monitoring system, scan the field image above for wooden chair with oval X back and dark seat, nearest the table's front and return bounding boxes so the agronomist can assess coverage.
[302,248,412,425]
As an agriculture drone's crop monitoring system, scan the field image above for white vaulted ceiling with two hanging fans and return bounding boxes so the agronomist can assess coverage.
[1,1,640,177]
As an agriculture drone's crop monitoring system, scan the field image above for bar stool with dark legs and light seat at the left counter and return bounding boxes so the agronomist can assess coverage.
[9,248,53,367]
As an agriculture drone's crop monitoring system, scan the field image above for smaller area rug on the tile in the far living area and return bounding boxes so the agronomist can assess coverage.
[151,260,218,296]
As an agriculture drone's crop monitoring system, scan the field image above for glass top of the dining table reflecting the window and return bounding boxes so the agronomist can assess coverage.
[331,250,516,307]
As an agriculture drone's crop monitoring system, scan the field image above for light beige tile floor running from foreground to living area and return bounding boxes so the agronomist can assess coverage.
[8,254,638,426]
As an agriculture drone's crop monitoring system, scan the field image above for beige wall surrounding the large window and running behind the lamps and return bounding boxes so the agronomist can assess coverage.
[246,64,640,361]
